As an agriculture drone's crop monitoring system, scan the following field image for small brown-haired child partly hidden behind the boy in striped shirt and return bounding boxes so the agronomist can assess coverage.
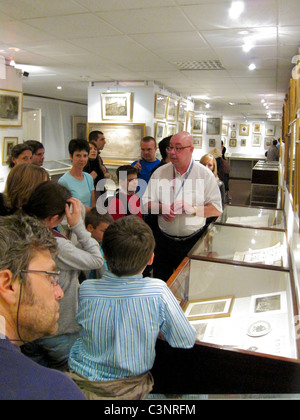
[85,207,114,279]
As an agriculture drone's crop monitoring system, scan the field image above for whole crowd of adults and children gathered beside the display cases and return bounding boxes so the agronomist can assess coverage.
[0,132,227,400]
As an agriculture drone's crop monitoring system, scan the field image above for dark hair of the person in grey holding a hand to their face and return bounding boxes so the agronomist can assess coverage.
[23,181,72,220]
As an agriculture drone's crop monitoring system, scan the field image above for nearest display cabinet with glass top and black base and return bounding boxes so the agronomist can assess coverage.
[152,256,300,394]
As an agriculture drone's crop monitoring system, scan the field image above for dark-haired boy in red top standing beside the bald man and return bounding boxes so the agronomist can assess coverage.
[107,165,142,220]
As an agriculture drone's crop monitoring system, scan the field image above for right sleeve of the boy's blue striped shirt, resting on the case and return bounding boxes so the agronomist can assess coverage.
[160,285,196,349]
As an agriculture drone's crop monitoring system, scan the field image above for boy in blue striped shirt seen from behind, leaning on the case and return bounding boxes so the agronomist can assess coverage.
[69,216,196,400]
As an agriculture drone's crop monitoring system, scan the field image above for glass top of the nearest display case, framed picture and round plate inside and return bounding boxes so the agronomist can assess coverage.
[168,259,299,359]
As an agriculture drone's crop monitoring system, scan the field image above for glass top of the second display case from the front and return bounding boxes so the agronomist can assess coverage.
[188,224,289,270]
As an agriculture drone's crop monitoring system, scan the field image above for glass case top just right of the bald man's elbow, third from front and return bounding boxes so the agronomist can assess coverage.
[216,206,286,230]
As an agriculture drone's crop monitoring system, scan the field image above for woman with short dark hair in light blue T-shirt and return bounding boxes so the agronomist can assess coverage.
[58,140,96,211]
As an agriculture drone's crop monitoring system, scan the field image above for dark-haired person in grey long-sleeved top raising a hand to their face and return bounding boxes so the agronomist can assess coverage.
[22,182,103,371]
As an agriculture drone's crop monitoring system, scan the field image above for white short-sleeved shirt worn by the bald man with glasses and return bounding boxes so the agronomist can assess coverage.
[143,160,223,237]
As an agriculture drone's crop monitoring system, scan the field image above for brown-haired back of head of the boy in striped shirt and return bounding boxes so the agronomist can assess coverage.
[102,216,155,277]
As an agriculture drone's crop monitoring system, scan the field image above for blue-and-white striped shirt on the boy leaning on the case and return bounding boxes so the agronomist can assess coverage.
[69,272,196,382]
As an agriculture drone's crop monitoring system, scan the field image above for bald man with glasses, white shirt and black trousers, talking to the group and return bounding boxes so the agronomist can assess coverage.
[143,132,222,281]
